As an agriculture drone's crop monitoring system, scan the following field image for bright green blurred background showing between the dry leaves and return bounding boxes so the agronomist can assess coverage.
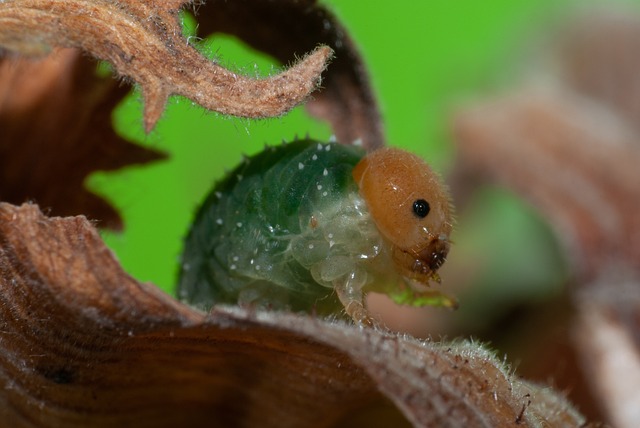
[88,0,566,307]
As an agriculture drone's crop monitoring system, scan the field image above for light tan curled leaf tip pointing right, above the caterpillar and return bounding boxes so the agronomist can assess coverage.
[0,0,332,131]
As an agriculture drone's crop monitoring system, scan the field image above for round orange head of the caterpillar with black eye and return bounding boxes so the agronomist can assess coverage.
[353,148,453,284]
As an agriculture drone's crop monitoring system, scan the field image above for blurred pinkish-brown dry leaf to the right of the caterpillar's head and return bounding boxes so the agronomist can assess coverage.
[455,88,640,277]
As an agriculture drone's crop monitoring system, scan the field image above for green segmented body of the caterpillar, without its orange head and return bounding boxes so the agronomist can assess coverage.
[178,140,372,311]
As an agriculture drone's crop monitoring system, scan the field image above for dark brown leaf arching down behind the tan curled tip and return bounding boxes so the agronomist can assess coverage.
[195,0,384,149]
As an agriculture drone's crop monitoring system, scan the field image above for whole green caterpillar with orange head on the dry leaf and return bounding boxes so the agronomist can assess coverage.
[178,140,456,325]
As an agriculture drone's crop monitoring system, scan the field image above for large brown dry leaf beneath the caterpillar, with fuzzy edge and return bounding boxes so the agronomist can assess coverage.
[0,204,584,427]
